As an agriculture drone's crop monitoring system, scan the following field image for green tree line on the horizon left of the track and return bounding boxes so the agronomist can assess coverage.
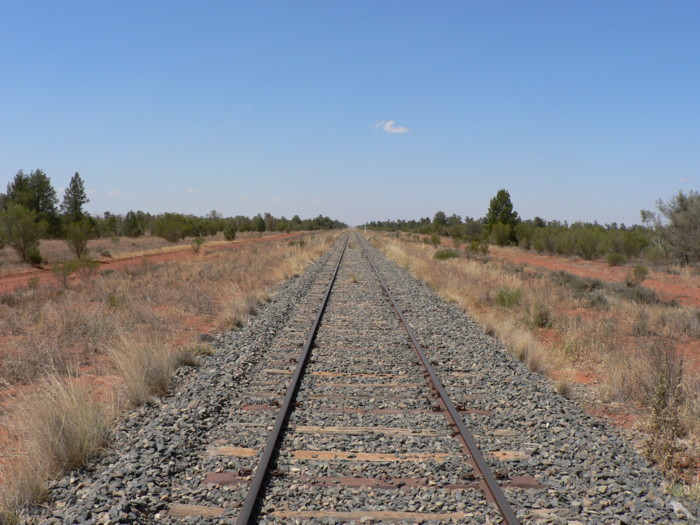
[0,170,347,264]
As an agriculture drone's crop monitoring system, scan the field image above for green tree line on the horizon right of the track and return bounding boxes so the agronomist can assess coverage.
[364,189,700,264]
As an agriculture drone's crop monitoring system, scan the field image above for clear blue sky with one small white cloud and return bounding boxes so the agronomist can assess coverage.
[0,0,700,224]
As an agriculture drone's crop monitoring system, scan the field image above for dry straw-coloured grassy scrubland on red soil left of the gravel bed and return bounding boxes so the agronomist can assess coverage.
[0,234,335,523]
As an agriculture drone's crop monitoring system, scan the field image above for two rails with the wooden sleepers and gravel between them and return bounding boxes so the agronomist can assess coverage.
[190,233,519,524]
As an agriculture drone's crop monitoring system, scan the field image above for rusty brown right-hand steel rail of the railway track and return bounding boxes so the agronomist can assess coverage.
[355,232,520,525]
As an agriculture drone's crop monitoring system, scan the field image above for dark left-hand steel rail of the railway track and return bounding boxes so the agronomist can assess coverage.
[236,234,350,525]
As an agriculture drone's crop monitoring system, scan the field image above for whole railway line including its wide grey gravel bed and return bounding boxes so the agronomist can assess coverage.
[28,233,675,525]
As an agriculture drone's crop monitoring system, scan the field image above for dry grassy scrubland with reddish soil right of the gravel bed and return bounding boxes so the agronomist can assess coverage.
[373,234,700,498]
